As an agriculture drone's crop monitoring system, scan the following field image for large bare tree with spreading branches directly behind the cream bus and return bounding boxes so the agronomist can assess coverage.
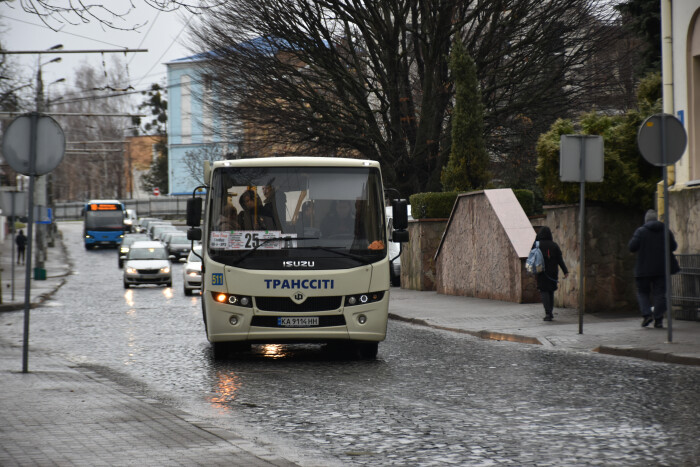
[193,0,628,195]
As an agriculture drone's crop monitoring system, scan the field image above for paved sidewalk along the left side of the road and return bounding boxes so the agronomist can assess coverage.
[0,234,296,467]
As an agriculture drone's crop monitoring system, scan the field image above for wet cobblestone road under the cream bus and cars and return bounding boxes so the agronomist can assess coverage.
[0,225,700,466]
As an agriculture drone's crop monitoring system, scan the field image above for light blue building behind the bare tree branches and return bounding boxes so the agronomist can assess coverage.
[165,54,241,195]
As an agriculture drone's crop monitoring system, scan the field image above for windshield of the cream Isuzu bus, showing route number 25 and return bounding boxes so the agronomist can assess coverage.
[207,167,386,269]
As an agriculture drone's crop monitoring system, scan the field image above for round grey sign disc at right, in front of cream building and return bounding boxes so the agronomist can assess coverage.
[637,114,688,167]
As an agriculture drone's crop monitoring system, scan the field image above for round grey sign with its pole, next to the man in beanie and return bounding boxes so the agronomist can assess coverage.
[637,114,688,342]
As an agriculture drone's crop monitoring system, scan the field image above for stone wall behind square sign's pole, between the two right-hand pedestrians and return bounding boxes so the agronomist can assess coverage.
[533,205,644,313]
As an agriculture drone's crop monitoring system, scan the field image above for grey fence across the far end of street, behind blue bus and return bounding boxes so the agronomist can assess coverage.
[53,196,205,220]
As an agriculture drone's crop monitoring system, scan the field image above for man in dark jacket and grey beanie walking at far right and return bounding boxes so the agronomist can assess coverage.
[628,209,677,328]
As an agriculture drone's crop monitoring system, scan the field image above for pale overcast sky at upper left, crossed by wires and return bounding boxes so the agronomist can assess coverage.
[0,0,193,103]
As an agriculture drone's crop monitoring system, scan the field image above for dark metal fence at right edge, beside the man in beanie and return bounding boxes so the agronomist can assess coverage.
[671,255,700,321]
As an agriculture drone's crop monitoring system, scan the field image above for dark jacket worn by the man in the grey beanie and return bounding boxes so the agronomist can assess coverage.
[628,221,678,277]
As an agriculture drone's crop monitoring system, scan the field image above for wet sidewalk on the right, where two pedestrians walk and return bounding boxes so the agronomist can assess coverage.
[389,288,700,365]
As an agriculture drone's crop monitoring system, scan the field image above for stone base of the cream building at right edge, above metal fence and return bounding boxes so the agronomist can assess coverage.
[668,186,700,255]
